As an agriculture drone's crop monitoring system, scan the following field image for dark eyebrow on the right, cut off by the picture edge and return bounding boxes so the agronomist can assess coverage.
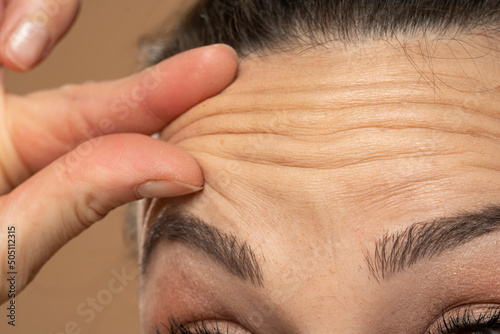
[365,206,500,282]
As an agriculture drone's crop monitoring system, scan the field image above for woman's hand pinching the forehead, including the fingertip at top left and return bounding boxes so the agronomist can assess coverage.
[0,0,237,303]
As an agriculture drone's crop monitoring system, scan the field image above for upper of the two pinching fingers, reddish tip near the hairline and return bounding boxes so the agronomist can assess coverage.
[7,45,238,172]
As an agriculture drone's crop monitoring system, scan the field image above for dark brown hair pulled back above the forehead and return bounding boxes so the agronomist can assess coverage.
[141,0,500,64]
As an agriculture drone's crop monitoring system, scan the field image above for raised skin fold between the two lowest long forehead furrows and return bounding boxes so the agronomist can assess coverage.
[172,128,500,174]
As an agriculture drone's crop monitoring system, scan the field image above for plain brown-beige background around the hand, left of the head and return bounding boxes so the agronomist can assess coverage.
[0,0,193,334]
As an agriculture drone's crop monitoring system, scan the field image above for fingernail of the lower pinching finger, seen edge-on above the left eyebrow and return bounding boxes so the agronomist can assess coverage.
[135,181,203,198]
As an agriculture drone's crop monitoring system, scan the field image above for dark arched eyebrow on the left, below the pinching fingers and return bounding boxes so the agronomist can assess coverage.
[141,210,263,286]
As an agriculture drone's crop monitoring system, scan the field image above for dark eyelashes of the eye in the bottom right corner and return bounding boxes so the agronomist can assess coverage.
[426,307,500,334]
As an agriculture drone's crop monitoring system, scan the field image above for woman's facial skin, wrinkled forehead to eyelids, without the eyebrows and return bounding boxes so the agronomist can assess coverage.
[139,34,500,334]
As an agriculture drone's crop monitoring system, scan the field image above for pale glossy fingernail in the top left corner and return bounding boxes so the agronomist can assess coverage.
[7,21,49,70]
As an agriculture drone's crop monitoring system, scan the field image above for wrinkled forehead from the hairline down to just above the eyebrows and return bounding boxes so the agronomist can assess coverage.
[159,36,500,224]
